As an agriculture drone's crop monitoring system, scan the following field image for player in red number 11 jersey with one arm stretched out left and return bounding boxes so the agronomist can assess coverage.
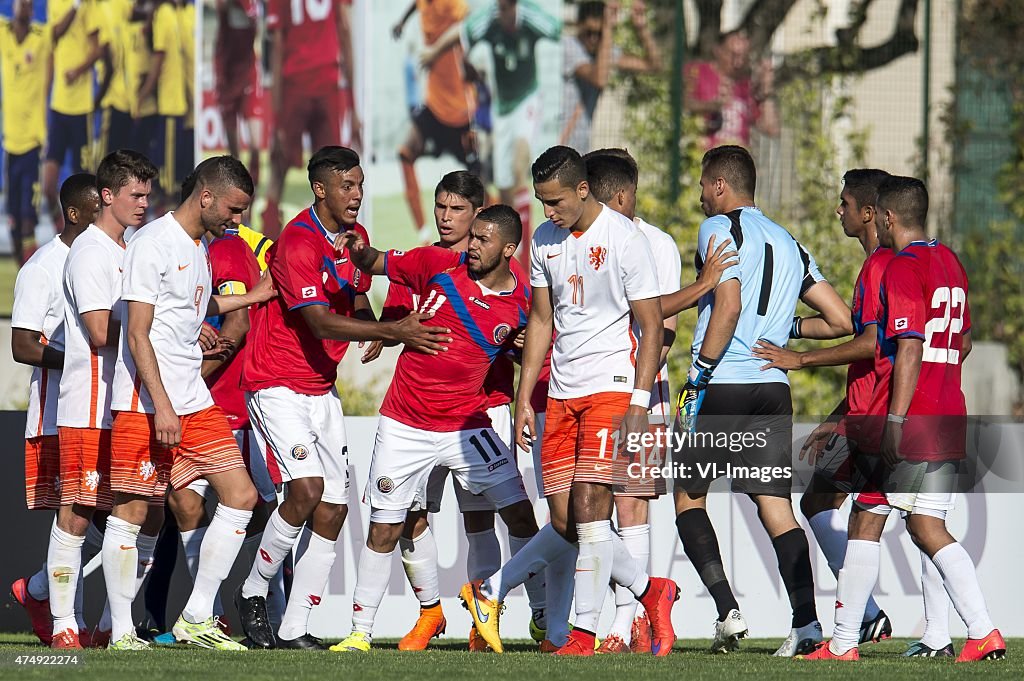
[331,205,537,652]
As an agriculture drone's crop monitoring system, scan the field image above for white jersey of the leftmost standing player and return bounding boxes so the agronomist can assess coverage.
[10,237,71,439]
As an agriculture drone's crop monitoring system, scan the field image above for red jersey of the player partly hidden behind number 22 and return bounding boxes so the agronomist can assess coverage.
[836,247,893,440]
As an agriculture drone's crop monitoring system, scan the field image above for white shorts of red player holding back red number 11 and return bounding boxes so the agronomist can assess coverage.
[246,386,348,504]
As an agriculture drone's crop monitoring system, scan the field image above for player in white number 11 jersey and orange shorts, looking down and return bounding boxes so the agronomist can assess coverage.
[460,146,678,655]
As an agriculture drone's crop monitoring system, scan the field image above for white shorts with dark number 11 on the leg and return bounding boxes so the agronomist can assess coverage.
[362,416,525,511]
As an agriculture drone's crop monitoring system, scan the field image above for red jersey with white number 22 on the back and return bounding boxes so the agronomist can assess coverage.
[869,240,971,461]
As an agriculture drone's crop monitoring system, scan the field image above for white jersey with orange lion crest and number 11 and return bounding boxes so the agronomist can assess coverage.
[529,206,658,399]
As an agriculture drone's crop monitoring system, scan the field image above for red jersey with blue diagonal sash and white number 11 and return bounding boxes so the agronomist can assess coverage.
[381,246,530,432]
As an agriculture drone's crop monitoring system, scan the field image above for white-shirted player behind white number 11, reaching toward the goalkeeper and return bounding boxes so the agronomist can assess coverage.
[584,148,734,653]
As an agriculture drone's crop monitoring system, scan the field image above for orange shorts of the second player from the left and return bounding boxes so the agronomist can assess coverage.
[57,427,114,511]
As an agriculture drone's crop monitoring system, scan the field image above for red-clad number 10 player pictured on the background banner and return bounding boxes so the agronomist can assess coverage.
[262,0,361,239]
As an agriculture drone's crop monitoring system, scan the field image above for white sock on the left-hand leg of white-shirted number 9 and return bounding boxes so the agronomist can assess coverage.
[101,515,142,642]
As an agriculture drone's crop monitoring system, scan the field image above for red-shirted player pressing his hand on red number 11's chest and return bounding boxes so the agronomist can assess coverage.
[238,146,447,648]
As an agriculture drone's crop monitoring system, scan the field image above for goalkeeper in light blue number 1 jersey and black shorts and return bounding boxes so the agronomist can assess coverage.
[673,146,852,657]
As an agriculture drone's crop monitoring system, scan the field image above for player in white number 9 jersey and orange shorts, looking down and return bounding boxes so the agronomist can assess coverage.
[103,157,273,650]
